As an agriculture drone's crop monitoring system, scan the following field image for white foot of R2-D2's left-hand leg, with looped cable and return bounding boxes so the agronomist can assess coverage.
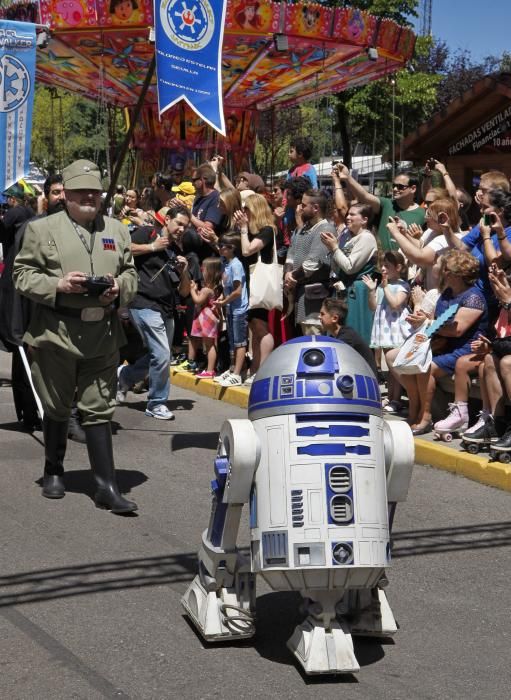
[181,576,255,642]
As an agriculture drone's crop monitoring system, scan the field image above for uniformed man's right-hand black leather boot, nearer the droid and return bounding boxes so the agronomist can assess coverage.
[84,423,138,513]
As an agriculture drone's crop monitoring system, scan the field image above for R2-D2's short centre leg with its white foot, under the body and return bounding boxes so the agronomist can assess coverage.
[287,589,360,675]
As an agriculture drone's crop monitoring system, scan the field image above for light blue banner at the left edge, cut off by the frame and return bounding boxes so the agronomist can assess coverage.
[0,20,36,192]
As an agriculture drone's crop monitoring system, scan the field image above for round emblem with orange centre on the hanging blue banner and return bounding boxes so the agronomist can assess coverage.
[160,0,215,51]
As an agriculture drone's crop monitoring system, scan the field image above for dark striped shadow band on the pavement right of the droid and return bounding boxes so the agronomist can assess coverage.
[392,522,511,558]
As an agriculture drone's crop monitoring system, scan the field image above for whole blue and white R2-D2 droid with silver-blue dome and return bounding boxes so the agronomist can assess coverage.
[182,336,414,674]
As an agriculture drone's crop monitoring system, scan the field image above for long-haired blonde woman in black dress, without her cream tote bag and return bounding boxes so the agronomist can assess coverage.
[233,194,276,384]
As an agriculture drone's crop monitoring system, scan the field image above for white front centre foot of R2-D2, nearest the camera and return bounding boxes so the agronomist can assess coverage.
[287,617,360,675]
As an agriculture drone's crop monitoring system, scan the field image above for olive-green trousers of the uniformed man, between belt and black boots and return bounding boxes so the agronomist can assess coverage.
[31,345,119,426]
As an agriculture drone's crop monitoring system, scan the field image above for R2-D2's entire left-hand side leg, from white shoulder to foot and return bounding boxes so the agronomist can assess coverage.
[181,420,260,642]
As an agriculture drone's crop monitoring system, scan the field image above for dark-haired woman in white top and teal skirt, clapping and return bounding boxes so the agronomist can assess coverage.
[321,204,378,343]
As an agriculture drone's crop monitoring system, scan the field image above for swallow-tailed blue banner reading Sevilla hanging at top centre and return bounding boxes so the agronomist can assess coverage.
[154,0,227,136]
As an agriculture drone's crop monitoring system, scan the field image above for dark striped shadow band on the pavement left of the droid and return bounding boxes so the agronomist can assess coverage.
[0,552,197,607]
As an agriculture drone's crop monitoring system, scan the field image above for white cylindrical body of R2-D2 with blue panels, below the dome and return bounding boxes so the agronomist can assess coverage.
[250,413,389,590]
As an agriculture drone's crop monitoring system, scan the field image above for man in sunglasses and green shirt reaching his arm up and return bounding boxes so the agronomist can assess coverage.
[337,163,425,250]
